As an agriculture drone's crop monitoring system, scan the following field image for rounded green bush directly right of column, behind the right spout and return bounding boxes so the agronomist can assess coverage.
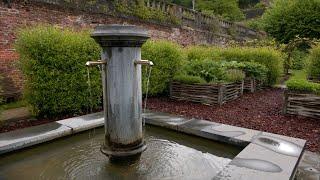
[142,40,183,95]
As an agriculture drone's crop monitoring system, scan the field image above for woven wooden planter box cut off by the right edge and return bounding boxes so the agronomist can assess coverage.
[283,90,320,119]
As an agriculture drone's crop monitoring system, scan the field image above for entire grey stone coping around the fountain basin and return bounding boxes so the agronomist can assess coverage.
[0,112,306,180]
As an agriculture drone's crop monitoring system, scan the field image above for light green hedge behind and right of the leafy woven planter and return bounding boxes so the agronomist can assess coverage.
[221,47,283,85]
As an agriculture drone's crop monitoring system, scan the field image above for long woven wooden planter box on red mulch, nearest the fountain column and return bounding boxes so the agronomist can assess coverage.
[170,82,243,105]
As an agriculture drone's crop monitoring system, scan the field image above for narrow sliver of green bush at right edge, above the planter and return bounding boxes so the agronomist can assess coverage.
[308,45,320,79]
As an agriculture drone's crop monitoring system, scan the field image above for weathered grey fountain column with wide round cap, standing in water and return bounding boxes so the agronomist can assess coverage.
[91,25,149,157]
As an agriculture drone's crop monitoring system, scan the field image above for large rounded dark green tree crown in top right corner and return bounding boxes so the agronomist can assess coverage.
[262,0,320,43]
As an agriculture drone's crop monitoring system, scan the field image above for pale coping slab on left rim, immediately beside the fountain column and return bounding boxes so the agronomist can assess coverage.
[57,112,104,133]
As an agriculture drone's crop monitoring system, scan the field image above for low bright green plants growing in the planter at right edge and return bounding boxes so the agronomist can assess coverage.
[286,70,320,95]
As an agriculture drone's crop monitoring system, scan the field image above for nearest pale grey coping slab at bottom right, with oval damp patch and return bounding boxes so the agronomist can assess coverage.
[214,143,303,180]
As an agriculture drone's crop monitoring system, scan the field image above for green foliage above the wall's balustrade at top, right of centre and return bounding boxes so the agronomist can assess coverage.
[196,0,244,21]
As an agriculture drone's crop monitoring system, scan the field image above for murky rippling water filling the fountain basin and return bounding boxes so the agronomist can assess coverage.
[0,126,241,180]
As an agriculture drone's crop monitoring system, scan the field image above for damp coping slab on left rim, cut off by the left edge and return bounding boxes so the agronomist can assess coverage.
[0,122,72,154]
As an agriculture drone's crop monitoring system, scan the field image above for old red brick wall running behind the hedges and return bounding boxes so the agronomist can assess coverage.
[0,0,235,96]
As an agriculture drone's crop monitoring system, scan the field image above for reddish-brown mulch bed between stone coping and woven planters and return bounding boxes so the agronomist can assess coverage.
[148,89,320,152]
